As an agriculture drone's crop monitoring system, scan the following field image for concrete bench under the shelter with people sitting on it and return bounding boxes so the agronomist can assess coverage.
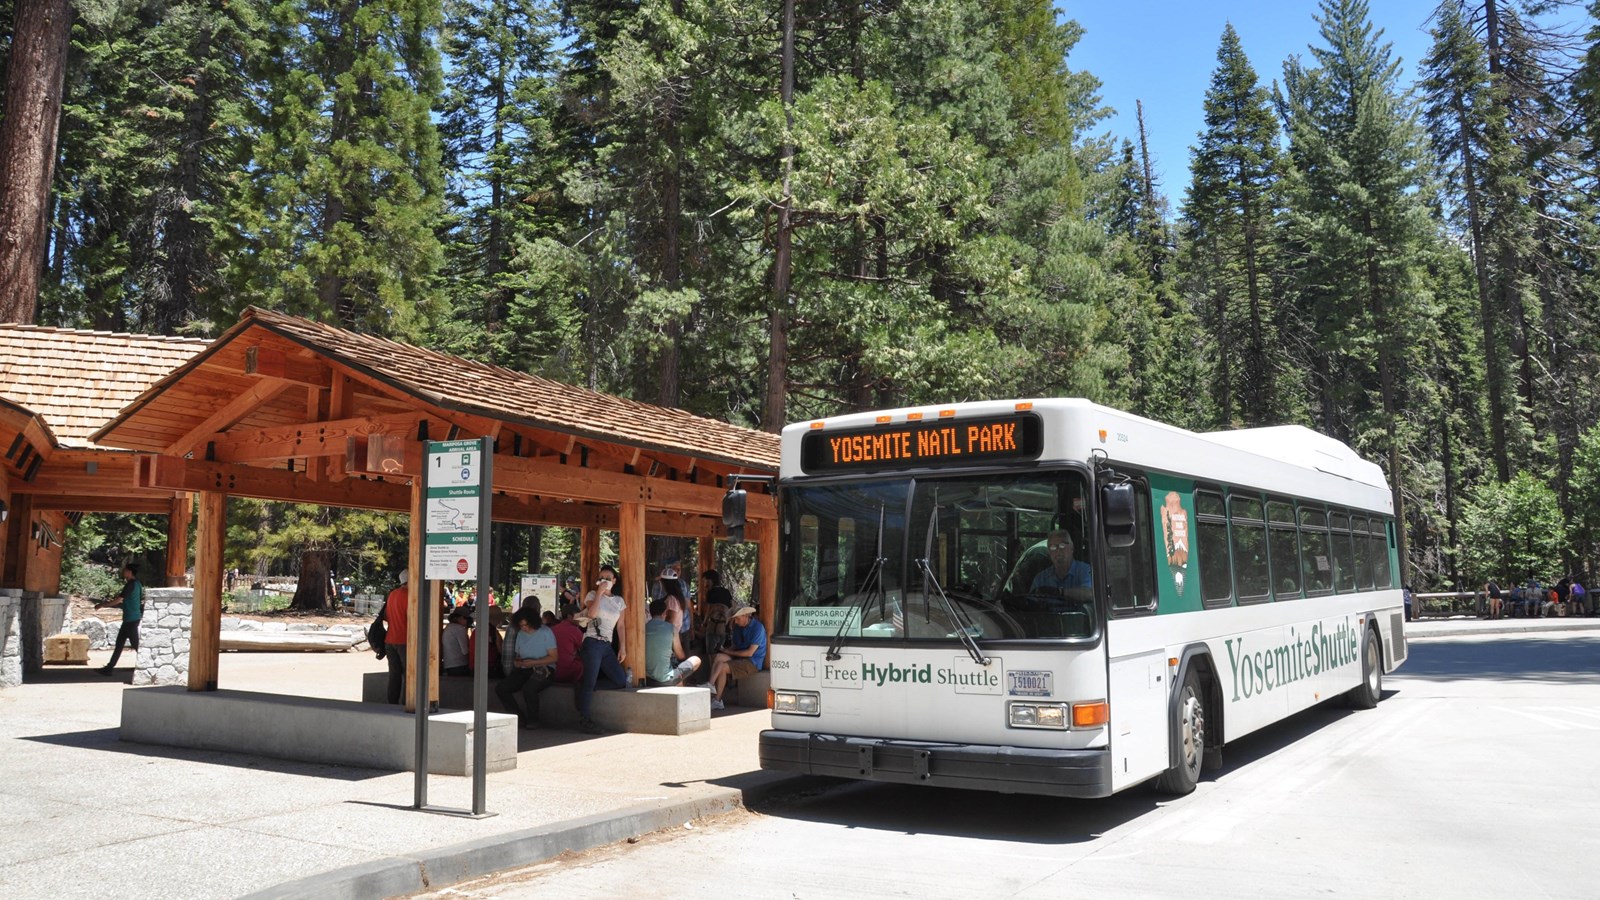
[362,673,716,735]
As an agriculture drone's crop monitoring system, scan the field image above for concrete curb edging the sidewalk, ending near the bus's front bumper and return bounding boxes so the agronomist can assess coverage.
[245,772,834,900]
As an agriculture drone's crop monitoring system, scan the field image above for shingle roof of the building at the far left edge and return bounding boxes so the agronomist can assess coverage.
[0,323,208,448]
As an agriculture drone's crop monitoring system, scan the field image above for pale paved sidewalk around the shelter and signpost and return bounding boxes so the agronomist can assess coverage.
[0,653,808,900]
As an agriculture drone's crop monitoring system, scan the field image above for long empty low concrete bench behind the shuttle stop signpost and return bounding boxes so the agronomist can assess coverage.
[122,685,517,775]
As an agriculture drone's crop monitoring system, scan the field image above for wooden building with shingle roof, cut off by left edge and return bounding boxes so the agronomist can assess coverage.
[0,323,208,594]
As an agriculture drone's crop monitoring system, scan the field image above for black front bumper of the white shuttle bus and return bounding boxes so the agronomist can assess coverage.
[760,730,1110,798]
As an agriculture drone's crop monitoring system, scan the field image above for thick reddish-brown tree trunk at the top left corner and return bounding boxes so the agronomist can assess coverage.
[0,0,72,325]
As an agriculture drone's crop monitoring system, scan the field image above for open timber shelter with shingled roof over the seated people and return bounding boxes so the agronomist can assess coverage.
[93,309,778,706]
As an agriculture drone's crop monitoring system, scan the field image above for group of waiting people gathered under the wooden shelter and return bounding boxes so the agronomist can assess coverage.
[379,560,766,733]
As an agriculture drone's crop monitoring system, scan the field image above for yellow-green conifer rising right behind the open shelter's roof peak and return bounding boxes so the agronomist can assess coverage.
[230,0,443,335]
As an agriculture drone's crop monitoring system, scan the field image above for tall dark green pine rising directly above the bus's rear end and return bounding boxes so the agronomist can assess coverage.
[1283,0,1434,578]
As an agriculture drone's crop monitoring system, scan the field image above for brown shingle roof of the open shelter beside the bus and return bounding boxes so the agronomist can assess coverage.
[101,307,779,471]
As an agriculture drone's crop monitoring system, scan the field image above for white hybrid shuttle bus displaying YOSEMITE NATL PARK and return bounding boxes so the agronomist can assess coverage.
[760,399,1406,798]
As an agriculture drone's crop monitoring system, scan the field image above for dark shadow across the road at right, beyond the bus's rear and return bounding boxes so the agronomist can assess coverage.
[1389,636,1600,684]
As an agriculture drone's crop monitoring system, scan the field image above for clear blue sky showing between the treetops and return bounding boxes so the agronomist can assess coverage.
[1056,0,1438,206]
